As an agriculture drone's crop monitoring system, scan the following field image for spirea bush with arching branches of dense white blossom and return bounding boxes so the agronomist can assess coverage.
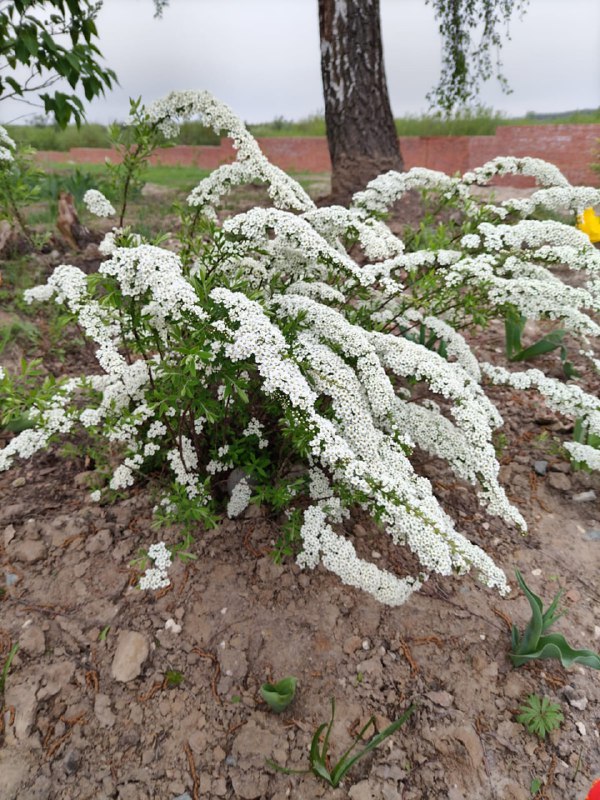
[0,92,600,605]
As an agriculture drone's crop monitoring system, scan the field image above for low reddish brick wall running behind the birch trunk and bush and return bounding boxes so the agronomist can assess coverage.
[38,124,600,186]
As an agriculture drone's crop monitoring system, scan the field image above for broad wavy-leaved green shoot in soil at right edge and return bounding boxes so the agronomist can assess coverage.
[510,570,600,669]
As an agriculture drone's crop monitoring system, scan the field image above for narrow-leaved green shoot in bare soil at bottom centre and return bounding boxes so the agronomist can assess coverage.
[267,697,415,789]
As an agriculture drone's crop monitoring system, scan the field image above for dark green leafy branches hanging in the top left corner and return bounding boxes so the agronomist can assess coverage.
[0,0,117,128]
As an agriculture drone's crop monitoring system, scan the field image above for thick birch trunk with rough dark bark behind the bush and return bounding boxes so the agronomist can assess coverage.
[319,0,403,205]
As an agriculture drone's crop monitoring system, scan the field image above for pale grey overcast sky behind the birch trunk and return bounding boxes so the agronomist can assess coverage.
[1,0,600,122]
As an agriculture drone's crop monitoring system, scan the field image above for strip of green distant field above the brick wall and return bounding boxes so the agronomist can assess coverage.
[7,108,600,151]
